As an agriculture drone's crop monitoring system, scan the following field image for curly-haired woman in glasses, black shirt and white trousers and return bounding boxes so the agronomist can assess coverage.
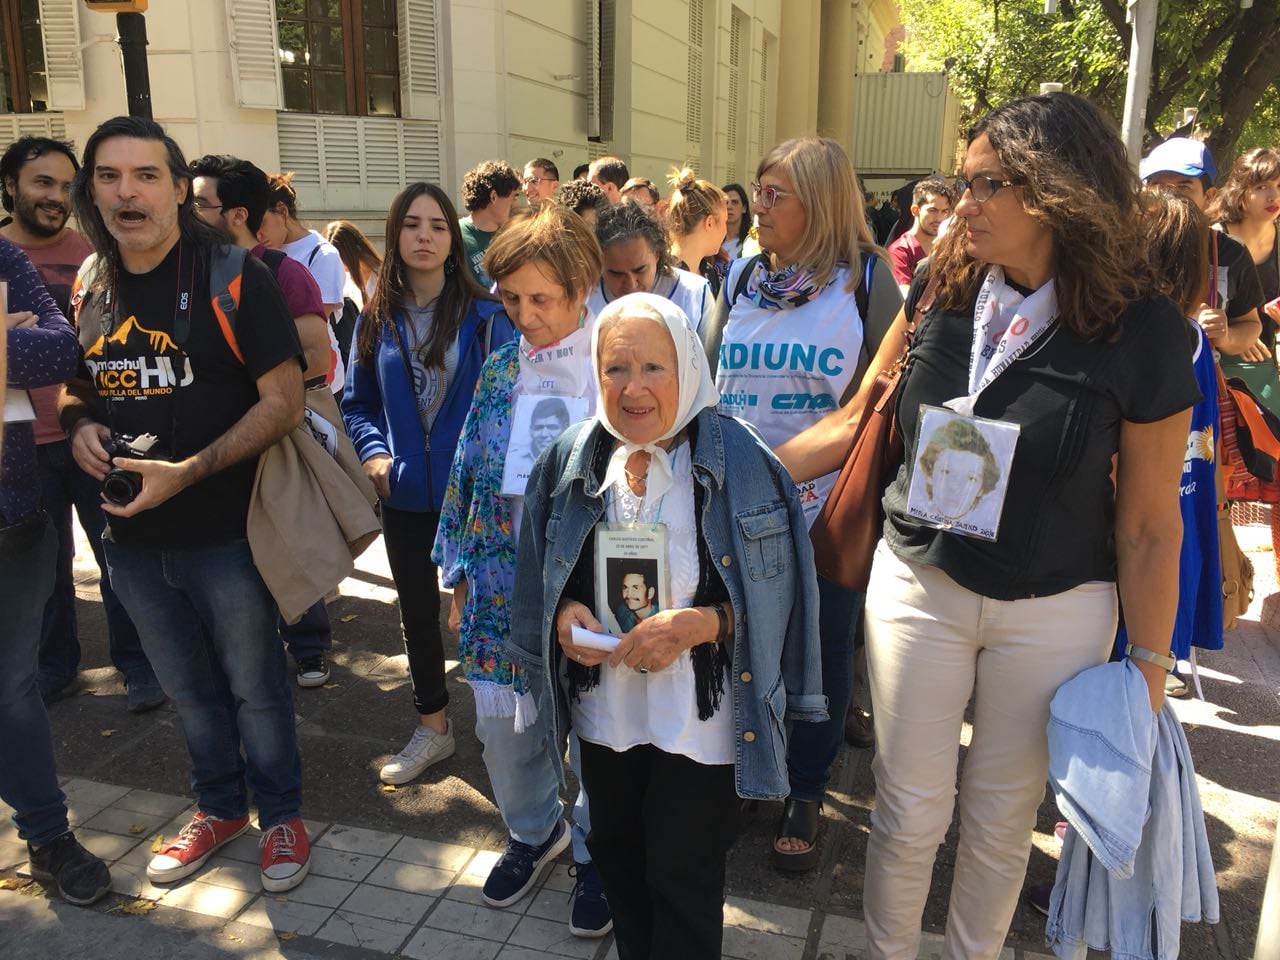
[841,93,1201,960]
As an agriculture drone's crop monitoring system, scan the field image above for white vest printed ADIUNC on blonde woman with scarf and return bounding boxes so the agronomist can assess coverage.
[716,260,863,525]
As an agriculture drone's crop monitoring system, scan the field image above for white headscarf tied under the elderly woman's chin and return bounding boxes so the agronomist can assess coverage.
[591,293,719,499]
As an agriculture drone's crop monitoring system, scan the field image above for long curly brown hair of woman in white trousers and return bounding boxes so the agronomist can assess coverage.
[931,93,1151,340]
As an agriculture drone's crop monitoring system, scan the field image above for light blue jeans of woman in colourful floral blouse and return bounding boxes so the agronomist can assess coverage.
[476,712,591,863]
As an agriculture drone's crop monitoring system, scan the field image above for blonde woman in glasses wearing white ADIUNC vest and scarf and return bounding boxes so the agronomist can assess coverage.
[712,137,897,872]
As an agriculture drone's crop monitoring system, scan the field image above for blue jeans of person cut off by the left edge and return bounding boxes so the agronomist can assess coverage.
[0,521,67,845]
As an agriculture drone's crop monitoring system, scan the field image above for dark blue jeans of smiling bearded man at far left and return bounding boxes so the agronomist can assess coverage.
[36,440,155,687]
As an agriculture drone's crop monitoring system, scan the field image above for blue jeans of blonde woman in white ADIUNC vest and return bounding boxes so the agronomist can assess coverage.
[787,577,864,800]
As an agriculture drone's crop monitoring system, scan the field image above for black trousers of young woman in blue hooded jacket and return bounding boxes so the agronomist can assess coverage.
[383,502,449,714]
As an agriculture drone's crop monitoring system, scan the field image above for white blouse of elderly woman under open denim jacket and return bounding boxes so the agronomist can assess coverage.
[572,443,733,764]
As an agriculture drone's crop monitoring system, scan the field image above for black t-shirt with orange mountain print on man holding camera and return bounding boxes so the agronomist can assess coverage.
[81,244,302,548]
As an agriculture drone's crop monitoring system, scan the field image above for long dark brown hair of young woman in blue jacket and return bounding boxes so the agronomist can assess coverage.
[356,182,493,367]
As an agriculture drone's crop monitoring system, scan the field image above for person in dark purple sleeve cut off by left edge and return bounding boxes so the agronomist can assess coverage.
[0,232,111,905]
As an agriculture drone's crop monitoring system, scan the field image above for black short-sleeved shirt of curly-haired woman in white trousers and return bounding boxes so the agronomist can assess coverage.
[884,273,1201,600]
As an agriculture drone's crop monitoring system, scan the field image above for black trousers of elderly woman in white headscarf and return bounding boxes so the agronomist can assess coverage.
[582,740,739,960]
